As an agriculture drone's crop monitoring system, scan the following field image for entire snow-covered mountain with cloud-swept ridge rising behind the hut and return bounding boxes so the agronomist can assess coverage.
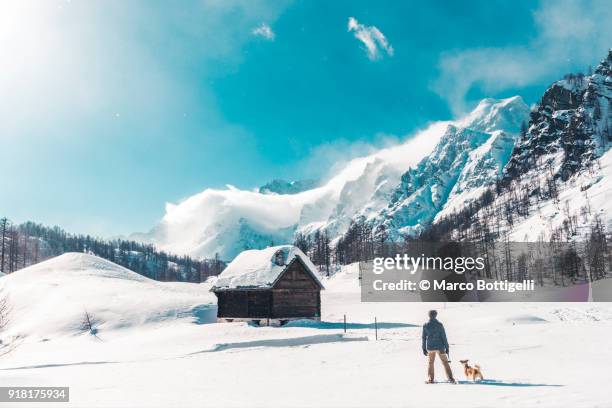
[138,97,528,259]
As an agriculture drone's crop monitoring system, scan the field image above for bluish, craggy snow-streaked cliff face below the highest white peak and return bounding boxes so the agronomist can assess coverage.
[372,97,529,239]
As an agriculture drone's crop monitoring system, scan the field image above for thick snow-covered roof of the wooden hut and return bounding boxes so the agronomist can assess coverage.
[212,245,323,291]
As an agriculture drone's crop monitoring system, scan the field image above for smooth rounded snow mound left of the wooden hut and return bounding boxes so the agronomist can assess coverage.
[0,253,216,338]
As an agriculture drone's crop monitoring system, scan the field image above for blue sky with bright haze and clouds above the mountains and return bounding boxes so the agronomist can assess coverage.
[0,0,612,236]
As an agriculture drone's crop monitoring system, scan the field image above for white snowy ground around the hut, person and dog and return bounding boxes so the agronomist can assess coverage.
[0,254,612,407]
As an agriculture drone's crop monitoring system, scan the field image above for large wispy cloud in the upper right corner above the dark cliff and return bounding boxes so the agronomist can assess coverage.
[433,0,612,114]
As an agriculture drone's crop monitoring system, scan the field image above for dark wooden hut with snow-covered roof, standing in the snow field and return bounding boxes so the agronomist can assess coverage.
[211,245,323,325]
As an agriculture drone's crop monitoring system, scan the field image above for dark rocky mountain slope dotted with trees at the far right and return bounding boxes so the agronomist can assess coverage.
[433,50,612,241]
